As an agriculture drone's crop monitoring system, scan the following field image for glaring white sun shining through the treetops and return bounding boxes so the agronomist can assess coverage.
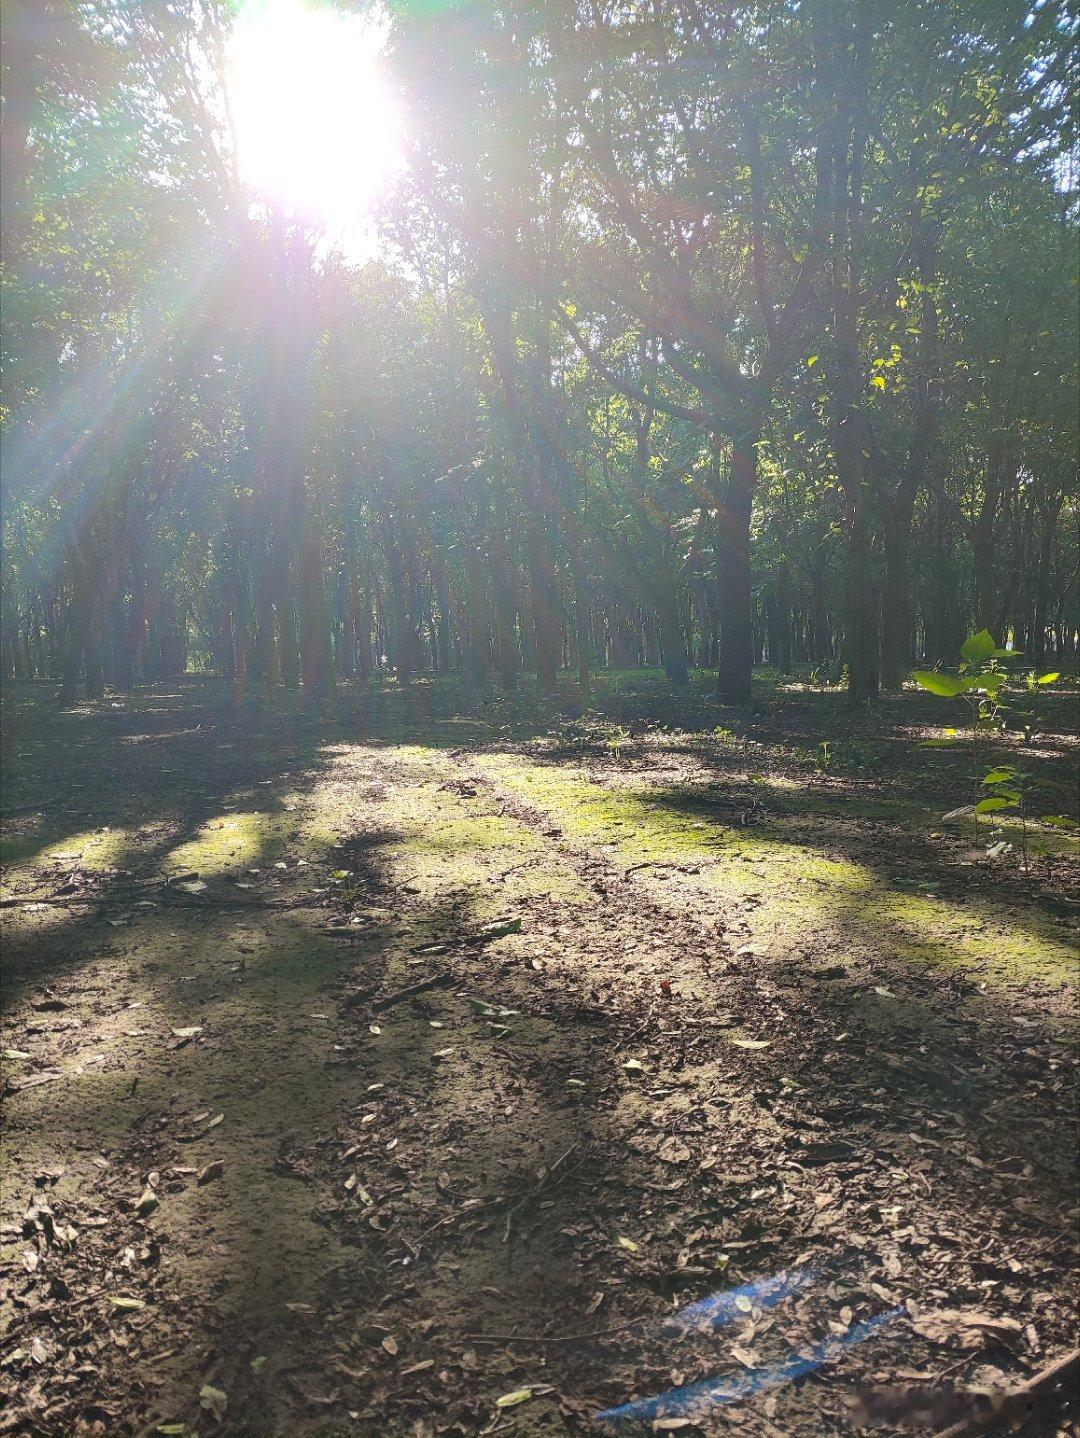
[227,0,401,236]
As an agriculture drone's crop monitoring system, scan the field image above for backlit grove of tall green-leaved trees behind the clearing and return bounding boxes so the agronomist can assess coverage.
[1,0,1080,703]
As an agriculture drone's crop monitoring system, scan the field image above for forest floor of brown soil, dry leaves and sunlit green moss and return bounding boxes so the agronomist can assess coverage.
[0,674,1079,1438]
